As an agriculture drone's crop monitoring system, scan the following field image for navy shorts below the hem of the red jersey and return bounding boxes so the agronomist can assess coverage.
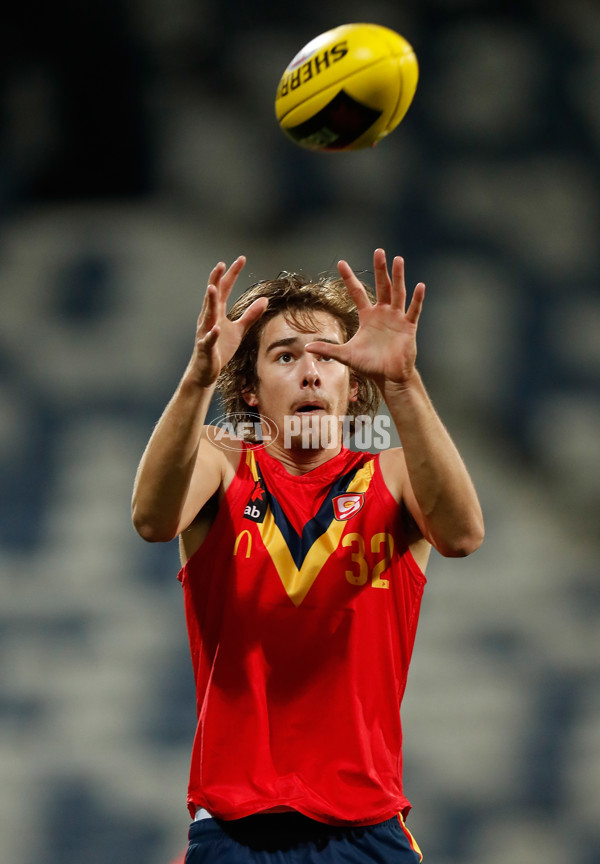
[185,813,421,864]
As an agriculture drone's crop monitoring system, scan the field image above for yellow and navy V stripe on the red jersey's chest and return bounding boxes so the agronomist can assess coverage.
[246,450,374,606]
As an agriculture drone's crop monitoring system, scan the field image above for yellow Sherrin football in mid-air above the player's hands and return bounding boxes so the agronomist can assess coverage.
[275,24,419,151]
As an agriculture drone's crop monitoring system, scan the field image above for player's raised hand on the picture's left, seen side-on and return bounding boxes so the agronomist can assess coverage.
[187,255,268,387]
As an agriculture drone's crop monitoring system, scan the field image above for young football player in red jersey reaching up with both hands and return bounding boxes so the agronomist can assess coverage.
[133,249,483,864]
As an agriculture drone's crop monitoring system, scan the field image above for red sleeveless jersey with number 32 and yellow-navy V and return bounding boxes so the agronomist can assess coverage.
[179,446,425,825]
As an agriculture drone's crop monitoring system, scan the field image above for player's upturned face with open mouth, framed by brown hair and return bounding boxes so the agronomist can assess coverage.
[246,311,357,449]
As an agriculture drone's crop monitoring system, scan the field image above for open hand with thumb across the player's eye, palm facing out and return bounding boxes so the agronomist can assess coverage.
[306,249,425,389]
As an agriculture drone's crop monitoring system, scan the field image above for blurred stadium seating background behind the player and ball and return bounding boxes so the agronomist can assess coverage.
[0,0,600,864]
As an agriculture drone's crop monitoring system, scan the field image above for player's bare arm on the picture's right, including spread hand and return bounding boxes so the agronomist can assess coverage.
[306,249,483,556]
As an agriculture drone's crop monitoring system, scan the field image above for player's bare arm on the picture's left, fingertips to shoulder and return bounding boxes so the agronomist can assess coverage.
[132,256,267,541]
